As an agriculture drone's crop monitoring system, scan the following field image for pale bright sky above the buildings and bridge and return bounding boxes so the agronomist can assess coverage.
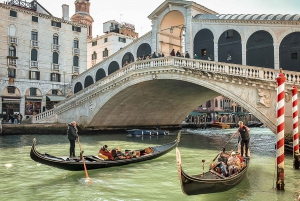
[37,0,300,37]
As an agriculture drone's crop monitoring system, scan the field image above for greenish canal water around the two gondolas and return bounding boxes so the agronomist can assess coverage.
[0,128,300,201]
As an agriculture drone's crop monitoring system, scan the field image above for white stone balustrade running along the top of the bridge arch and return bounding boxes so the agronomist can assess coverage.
[32,57,300,123]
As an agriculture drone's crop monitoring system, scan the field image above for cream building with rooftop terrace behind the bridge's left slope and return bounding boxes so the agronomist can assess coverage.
[87,20,138,68]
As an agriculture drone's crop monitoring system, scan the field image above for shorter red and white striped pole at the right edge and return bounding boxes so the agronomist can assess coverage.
[292,84,300,169]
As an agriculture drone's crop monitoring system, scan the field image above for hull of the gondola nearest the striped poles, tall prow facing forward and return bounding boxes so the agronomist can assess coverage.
[176,148,250,195]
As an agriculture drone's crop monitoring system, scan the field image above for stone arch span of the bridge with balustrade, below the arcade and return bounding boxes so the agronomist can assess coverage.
[33,57,300,133]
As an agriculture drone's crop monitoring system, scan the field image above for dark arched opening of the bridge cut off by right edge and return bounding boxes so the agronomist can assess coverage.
[279,32,300,72]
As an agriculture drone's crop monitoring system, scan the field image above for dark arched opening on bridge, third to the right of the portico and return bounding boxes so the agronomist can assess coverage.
[246,31,274,68]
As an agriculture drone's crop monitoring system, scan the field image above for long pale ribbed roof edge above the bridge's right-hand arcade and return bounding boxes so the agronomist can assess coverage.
[193,14,300,21]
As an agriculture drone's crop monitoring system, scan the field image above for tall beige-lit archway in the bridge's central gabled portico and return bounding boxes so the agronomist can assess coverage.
[158,10,185,55]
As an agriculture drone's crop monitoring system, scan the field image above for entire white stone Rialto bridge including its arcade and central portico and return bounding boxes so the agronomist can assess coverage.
[33,0,300,133]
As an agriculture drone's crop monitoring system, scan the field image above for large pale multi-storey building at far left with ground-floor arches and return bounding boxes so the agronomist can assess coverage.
[0,0,88,120]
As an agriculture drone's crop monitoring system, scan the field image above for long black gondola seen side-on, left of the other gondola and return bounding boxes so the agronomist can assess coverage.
[30,132,181,171]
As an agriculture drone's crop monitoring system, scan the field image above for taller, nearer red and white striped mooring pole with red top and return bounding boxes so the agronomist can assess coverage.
[276,69,286,190]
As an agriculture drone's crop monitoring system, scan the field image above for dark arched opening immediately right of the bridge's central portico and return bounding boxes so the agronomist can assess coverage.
[194,29,215,61]
